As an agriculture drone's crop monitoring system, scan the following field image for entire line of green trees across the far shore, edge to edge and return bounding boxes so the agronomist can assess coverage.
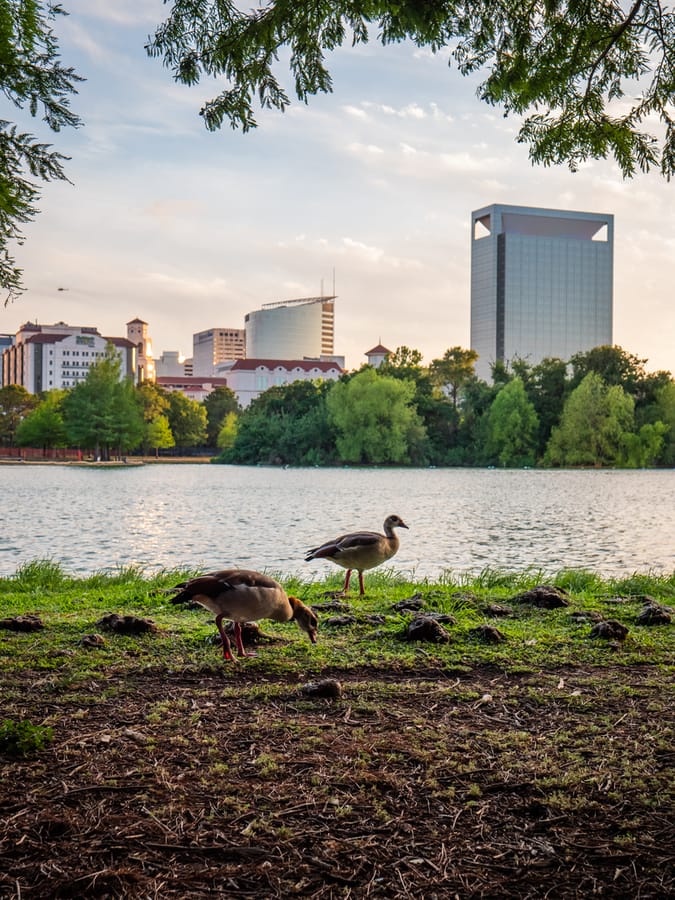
[0,346,675,467]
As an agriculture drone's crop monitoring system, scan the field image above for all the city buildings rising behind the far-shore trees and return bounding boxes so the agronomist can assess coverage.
[0,204,640,407]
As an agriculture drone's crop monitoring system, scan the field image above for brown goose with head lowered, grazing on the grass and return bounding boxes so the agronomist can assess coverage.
[171,569,317,659]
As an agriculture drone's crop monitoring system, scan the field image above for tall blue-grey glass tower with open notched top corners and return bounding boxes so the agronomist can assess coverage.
[471,204,614,379]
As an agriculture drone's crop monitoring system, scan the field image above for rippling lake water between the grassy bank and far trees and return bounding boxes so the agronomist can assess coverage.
[0,464,675,581]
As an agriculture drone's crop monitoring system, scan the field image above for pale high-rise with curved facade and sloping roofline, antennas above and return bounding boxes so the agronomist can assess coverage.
[245,295,336,359]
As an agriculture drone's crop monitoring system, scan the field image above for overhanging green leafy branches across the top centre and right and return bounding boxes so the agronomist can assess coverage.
[146,0,675,177]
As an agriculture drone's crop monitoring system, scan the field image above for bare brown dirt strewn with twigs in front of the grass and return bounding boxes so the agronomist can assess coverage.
[0,665,675,900]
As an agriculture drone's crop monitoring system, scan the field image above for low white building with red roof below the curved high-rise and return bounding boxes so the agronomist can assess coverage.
[219,359,344,407]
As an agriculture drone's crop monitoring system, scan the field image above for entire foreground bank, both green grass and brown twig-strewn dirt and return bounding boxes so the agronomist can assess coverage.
[0,562,675,900]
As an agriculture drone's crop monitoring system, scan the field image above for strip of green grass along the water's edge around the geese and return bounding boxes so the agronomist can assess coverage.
[0,560,675,691]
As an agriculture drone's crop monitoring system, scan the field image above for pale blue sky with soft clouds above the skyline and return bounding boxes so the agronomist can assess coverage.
[0,0,675,372]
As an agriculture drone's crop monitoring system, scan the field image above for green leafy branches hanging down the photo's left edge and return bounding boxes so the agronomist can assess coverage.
[0,0,82,304]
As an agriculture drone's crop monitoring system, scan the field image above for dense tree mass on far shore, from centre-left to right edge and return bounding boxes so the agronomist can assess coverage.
[217,346,675,467]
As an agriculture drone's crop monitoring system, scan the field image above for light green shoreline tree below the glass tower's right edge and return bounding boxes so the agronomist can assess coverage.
[545,372,635,466]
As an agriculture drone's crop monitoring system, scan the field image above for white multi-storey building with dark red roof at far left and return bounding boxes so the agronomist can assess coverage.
[2,322,136,394]
